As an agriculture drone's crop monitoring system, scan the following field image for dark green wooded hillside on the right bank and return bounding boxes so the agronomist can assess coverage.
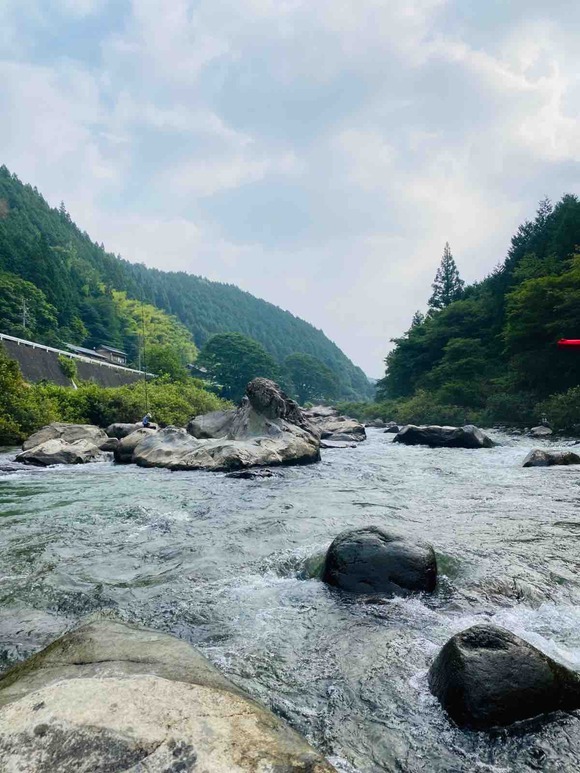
[378,195,580,426]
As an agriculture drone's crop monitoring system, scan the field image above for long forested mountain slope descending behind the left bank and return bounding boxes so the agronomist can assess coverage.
[0,167,370,398]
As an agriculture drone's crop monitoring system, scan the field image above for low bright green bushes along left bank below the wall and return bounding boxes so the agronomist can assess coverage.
[0,346,229,445]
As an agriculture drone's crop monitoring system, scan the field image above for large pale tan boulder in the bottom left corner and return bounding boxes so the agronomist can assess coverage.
[0,620,334,773]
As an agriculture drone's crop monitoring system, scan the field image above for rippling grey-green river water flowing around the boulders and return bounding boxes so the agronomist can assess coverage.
[0,430,580,773]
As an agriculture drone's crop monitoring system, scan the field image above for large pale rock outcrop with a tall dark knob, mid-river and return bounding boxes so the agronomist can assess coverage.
[125,378,320,470]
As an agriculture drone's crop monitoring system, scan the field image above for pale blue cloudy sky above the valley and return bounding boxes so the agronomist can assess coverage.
[0,0,580,377]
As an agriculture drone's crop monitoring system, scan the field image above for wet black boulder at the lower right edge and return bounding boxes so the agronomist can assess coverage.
[429,625,580,730]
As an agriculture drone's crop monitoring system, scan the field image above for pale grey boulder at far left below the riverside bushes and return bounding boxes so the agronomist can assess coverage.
[16,422,116,467]
